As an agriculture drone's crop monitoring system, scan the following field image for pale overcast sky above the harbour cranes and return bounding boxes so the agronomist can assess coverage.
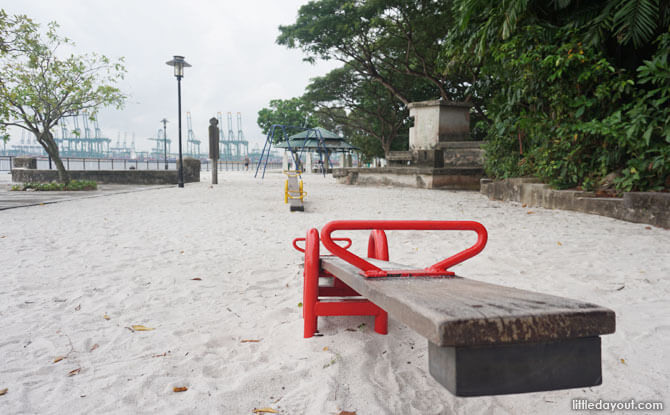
[0,0,337,152]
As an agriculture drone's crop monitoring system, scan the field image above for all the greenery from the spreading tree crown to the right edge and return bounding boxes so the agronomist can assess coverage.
[277,0,670,192]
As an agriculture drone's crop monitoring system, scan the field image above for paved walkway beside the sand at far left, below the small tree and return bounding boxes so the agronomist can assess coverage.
[0,172,173,210]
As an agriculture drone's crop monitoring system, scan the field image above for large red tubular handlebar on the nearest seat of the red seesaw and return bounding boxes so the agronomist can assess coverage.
[321,220,488,277]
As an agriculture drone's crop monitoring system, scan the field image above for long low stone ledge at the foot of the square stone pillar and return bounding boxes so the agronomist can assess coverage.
[333,167,484,190]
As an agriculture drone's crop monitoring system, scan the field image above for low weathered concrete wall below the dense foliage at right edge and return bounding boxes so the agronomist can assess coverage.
[480,178,670,229]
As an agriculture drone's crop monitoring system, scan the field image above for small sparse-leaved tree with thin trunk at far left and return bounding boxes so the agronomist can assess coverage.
[0,11,126,183]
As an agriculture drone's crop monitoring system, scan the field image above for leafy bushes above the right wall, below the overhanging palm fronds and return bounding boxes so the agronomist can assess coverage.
[486,27,670,191]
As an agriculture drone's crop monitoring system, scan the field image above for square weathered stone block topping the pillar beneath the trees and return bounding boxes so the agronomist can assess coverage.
[408,100,471,152]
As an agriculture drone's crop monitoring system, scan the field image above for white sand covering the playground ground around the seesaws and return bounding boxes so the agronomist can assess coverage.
[0,172,670,415]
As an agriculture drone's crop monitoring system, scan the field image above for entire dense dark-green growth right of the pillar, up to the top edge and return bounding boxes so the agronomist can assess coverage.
[452,0,670,192]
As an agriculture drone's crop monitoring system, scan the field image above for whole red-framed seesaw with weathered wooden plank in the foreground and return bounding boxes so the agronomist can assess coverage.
[293,220,615,396]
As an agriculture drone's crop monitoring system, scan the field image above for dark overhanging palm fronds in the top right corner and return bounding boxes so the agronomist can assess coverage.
[454,0,670,72]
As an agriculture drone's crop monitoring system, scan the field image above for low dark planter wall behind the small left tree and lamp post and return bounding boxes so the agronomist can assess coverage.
[12,169,200,184]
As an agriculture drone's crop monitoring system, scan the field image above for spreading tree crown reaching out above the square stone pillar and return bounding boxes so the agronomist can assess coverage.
[277,0,471,105]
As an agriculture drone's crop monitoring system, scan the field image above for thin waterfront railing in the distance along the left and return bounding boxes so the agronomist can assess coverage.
[0,156,281,172]
